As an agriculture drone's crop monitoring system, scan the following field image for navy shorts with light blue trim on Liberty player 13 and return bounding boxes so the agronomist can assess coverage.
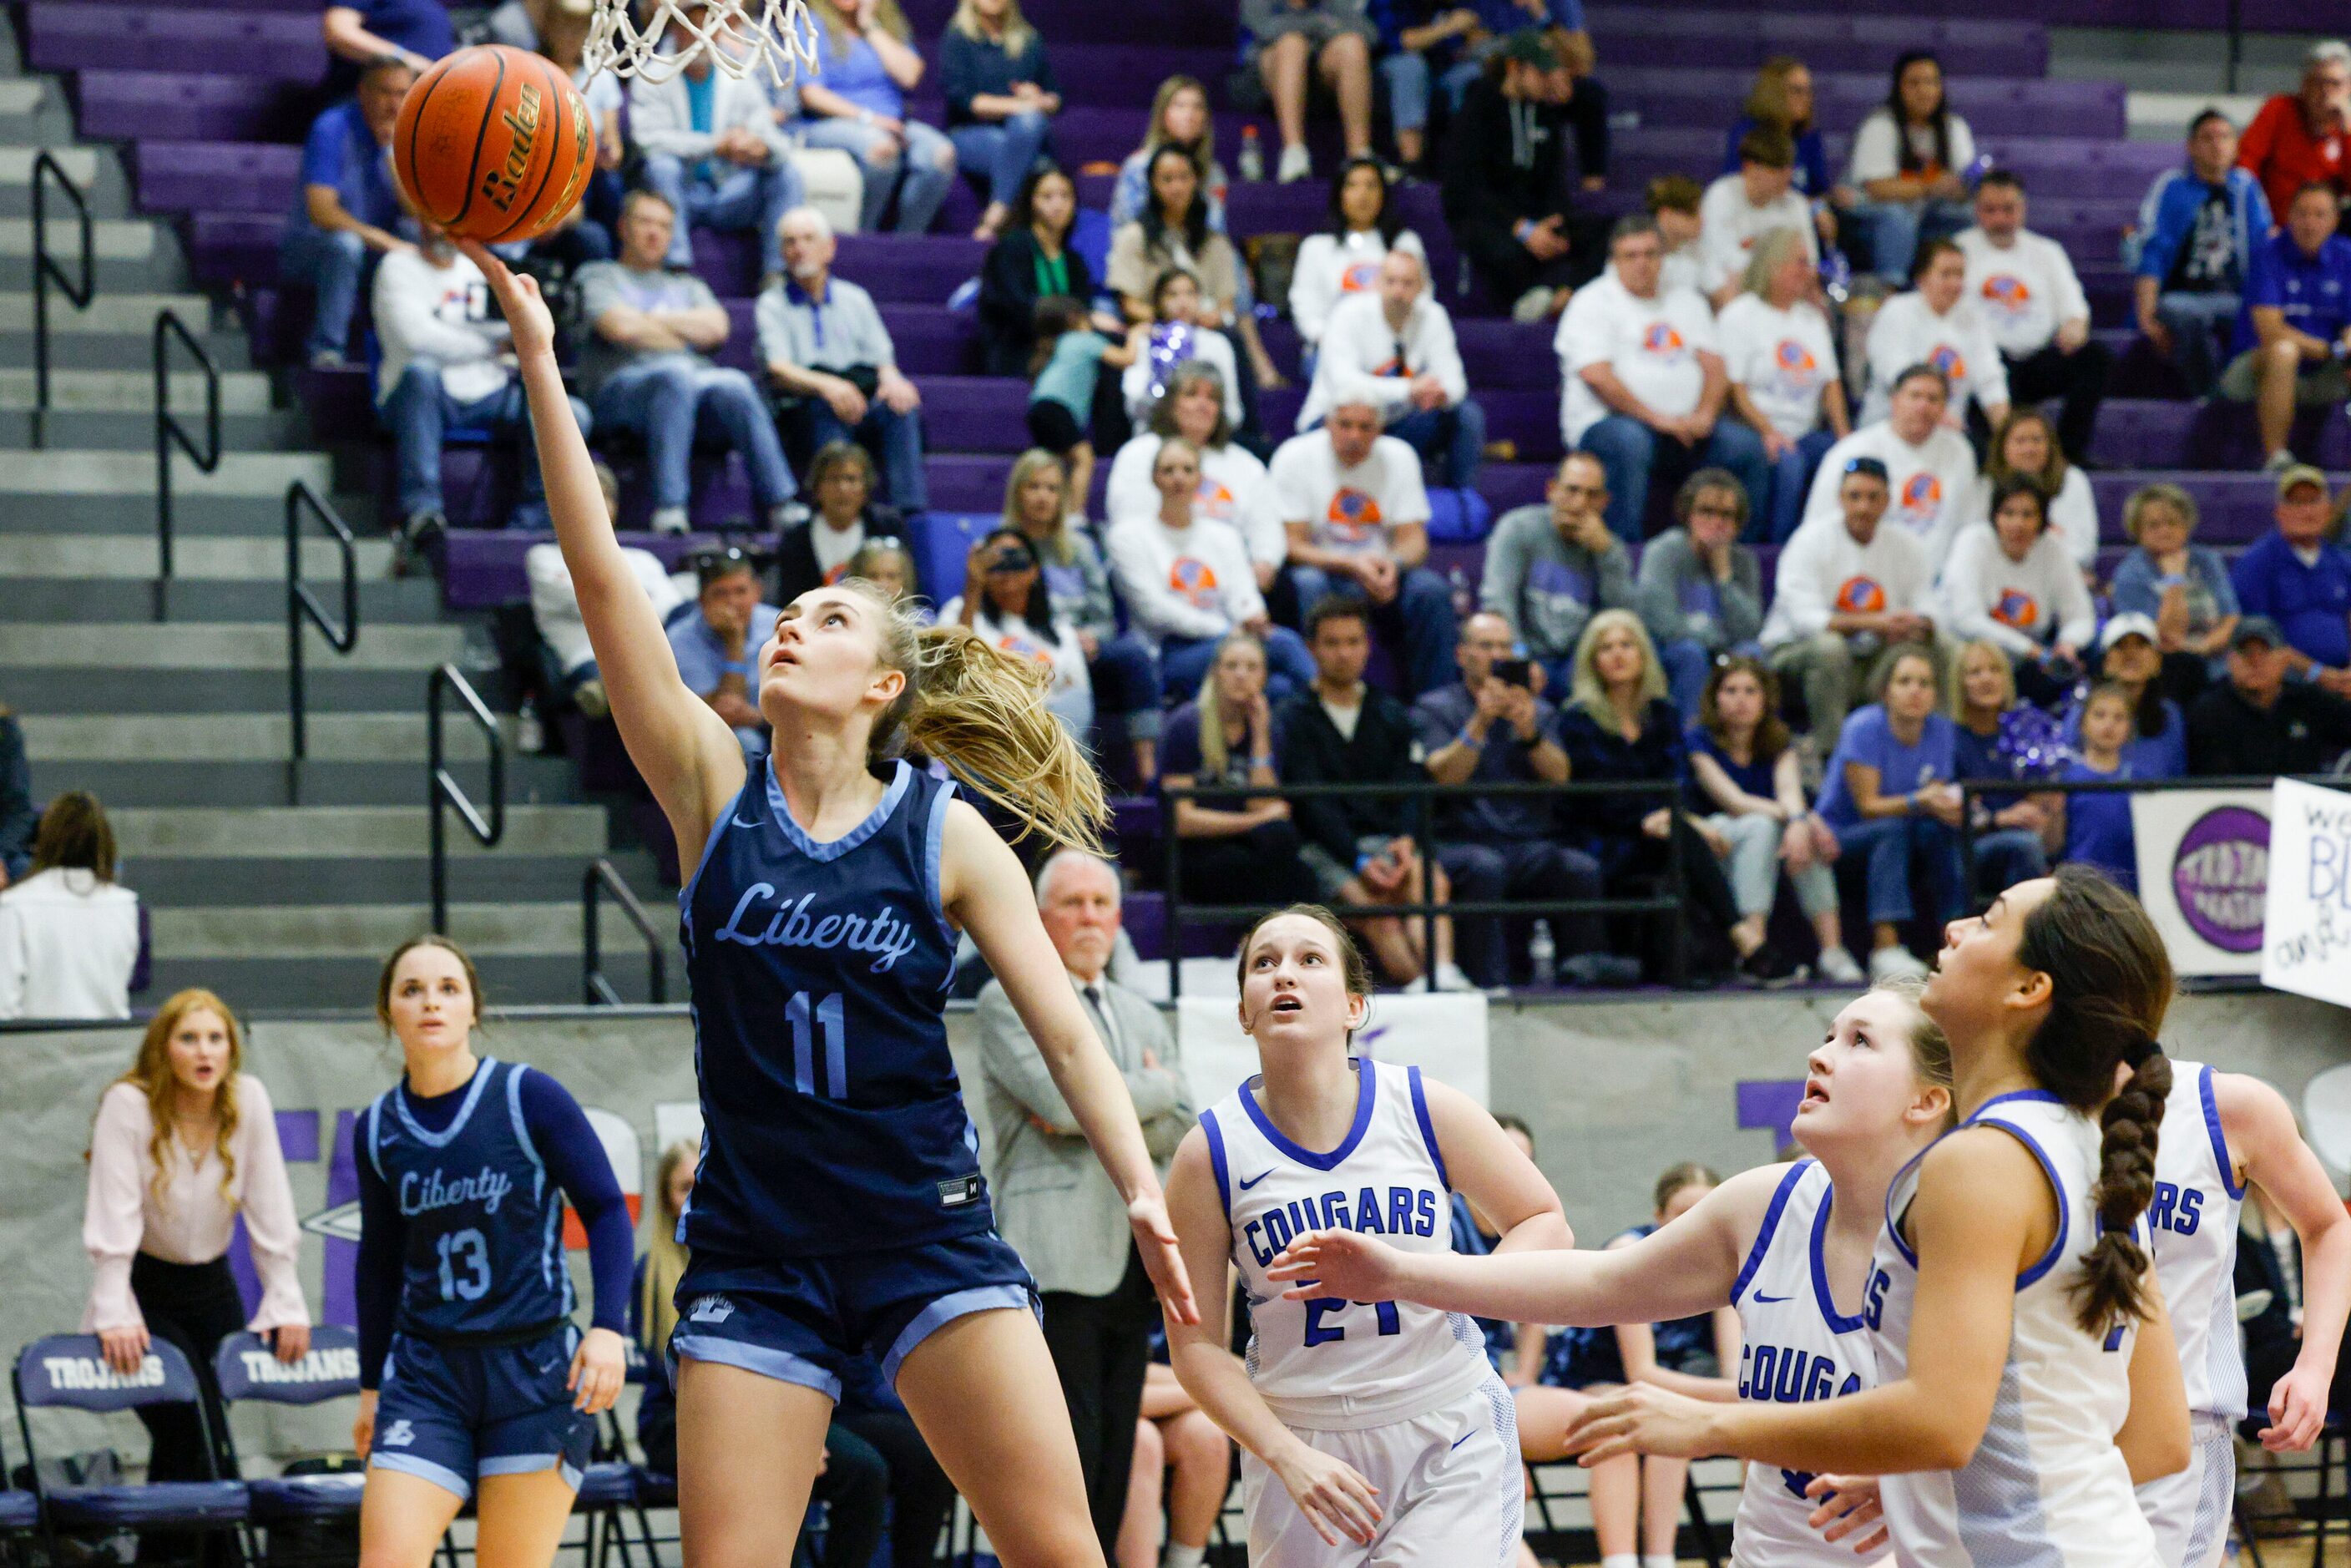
[367,1323,594,1498]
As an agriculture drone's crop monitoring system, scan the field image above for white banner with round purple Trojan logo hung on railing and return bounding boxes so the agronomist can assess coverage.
[2130,790,2268,975]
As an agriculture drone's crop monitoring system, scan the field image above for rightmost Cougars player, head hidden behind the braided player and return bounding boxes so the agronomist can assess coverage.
[2140,1060,2351,1568]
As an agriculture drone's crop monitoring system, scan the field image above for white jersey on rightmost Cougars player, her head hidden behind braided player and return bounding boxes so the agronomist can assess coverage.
[2146,1063,2245,1422]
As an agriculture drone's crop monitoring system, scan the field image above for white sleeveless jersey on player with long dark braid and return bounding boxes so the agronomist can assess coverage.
[1862,1089,2156,1568]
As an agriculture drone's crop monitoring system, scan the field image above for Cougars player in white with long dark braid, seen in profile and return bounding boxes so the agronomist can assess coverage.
[1542,865,2189,1568]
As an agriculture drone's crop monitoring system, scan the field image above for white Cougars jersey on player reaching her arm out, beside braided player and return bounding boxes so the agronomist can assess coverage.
[1731,1159,1873,1568]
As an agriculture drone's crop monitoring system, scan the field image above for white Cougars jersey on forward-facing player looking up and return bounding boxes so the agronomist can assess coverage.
[1199,1058,1490,1432]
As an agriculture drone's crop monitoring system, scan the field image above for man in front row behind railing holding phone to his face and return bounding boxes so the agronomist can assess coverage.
[1413,611,1641,985]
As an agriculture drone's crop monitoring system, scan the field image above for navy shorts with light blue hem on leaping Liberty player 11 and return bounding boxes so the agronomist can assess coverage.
[670,1230,1037,1401]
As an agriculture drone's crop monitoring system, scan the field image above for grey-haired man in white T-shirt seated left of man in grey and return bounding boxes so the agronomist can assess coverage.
[1272,397,1453,695]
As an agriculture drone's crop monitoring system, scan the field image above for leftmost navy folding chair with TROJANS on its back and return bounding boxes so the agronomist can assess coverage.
[9,1333,251,1568]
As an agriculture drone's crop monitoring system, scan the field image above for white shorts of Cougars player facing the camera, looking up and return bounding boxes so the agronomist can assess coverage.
[1241,1378,1526,1568]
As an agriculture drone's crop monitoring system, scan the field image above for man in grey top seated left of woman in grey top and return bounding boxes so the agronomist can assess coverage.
[1479,452,1646,691]
